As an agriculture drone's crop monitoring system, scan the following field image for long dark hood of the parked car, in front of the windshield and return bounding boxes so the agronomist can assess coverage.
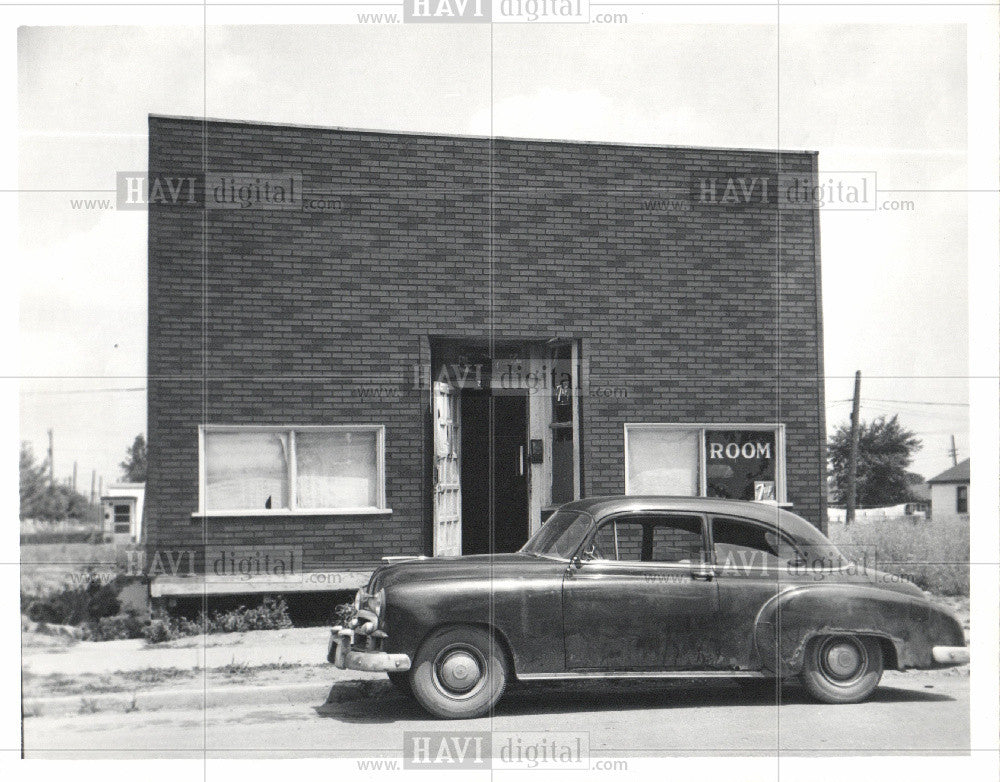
[368,553,566,592]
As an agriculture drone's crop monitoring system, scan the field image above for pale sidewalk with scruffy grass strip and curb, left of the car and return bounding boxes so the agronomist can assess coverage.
[22,627,390,717]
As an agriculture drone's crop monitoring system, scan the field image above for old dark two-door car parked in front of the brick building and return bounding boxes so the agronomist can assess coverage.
[328,497,969,718]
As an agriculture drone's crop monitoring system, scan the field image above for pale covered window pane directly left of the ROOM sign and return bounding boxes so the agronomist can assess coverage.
[628,428,699,497]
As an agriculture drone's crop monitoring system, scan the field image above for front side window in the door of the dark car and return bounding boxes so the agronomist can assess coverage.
[592,516,703,563]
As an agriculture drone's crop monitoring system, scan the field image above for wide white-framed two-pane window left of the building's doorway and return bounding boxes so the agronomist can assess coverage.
[201,426,385,514]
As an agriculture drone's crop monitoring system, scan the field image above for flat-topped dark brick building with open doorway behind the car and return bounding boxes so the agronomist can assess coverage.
[145,116,825,595]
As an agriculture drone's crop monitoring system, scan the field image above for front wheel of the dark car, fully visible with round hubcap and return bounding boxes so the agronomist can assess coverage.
[410,626,509,719]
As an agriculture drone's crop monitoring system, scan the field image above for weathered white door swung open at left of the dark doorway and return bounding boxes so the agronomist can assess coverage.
[431,382,462,557]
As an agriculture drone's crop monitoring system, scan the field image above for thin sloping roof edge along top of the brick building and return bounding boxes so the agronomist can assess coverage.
[149,112,819,157]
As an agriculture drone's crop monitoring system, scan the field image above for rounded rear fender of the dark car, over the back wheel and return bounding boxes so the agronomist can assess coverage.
[754,584,965,675]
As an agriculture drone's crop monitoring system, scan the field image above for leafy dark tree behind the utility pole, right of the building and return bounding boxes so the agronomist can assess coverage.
[828,415,923,508]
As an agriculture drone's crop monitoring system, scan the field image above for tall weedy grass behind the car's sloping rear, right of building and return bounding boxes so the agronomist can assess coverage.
[830,517,969,597]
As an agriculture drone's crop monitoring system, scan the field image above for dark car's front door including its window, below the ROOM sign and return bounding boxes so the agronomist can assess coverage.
[563,513,719,671]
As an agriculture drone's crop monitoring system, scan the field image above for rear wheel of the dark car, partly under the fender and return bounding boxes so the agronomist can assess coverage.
[801,635,882,703]
